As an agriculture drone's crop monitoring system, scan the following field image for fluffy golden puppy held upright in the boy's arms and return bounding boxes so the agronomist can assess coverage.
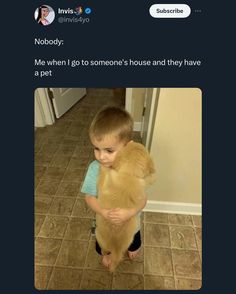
[96,141,155,271]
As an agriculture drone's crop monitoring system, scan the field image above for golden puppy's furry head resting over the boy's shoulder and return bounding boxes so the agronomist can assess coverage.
[112,141,155,182]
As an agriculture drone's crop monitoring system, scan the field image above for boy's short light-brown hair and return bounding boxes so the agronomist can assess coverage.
[89,106,133,142]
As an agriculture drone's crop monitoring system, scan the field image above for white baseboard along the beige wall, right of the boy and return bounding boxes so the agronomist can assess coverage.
[143,200,202,215]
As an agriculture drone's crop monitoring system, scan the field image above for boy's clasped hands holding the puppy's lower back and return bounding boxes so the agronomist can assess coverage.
[108,207,137,225]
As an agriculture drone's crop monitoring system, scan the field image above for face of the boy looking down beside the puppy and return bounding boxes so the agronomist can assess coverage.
[92,136,126,167]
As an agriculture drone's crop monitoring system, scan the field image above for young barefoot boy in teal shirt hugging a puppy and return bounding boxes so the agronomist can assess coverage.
[81,107,147,267]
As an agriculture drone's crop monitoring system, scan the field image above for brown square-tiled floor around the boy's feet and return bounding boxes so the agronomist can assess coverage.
[35,89,202,290]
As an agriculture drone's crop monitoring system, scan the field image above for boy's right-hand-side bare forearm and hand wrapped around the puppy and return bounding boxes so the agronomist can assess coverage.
[107,195,147,225]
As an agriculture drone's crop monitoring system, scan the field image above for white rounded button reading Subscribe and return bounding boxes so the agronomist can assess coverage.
[149,4,191,18]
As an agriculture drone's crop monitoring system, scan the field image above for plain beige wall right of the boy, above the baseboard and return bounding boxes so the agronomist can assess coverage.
[148,88,202,215]
